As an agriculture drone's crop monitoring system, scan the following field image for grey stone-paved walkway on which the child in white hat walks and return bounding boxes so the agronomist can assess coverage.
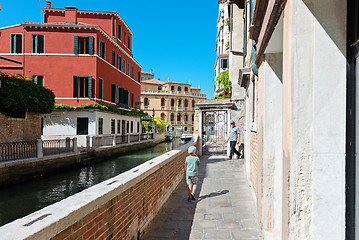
[141,155,262,240]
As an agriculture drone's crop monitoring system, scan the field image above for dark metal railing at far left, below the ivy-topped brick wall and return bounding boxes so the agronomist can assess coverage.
[0,141,37,161]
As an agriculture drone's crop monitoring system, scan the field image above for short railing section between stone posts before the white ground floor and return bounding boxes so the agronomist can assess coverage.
[42,138,74,156]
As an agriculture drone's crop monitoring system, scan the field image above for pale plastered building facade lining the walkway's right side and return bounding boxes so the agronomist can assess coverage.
[230,0,352,240]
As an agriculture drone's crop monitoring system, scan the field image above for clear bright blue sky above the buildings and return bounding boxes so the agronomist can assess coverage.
[0,0,218,98]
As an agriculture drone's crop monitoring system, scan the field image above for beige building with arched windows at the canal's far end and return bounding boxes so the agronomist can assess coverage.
[141,79,206,136]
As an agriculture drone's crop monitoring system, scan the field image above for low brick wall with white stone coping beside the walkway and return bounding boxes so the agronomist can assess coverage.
[0,136,198,240]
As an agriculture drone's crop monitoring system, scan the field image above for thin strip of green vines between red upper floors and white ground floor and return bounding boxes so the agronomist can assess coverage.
[55,102,146,117]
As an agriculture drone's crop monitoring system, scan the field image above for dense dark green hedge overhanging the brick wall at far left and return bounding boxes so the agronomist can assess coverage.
[0,72,55,115]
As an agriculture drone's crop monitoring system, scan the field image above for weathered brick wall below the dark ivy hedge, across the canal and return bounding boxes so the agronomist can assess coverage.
[0,112,41,142]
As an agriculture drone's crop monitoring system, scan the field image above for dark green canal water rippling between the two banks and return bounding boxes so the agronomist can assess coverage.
[0,138,184,226]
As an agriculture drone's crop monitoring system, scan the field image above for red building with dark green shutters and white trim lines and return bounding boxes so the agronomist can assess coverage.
[0,1,142,108]
